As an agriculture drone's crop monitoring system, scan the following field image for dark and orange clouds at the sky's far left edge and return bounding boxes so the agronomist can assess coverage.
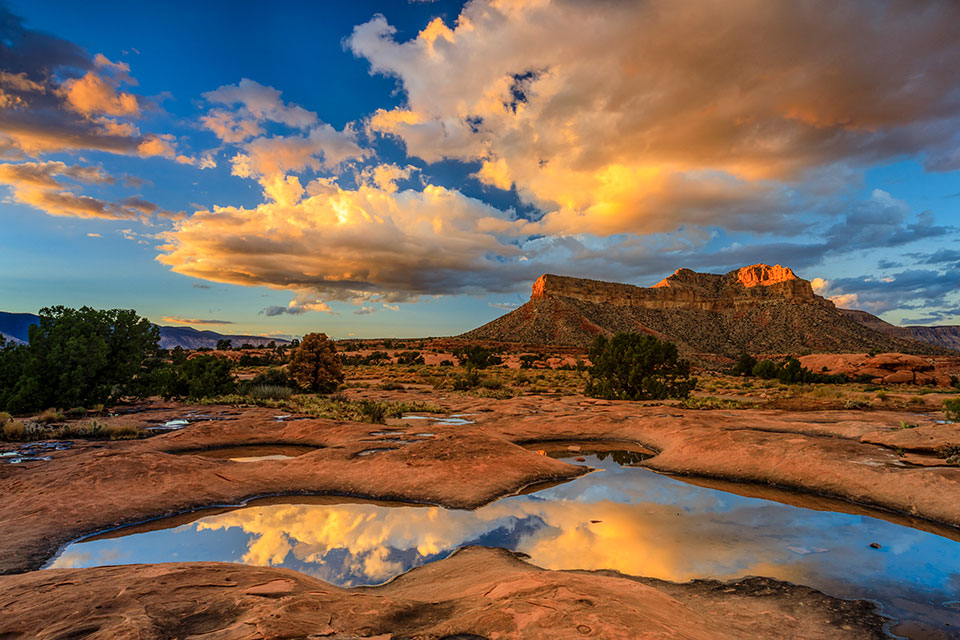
[0,5,193,219]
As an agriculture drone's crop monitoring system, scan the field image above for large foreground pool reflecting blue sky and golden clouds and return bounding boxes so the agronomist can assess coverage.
[52,447,960,630]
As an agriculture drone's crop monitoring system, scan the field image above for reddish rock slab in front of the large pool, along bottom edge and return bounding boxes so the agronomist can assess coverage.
[0,547,885,640]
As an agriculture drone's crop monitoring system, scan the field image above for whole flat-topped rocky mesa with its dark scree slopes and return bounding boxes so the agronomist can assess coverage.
[460,264,945,357]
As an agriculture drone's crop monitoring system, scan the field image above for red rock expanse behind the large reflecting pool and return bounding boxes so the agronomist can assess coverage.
[0,400,960,573]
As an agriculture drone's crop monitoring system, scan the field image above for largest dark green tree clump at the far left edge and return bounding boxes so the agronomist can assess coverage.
[0,306,160,413]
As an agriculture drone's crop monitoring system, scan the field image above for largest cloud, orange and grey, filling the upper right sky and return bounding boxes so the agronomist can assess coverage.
[347,0,960,235]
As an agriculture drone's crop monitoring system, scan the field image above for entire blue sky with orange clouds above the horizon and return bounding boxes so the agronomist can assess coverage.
[0,0,960,338]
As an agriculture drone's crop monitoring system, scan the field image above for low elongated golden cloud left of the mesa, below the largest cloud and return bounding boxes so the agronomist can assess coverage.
[158,172,529,314]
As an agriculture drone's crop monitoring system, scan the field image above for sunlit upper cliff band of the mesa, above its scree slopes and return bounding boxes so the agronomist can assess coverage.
[530,264,816,311]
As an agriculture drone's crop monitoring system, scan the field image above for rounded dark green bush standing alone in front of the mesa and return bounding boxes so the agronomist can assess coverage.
[586,333,697,400]
